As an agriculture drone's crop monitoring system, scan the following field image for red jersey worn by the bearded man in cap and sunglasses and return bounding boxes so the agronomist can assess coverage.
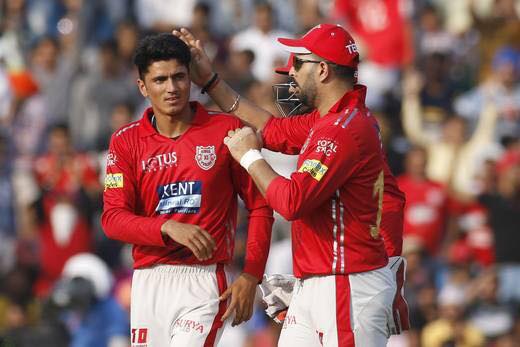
[263,85,404,277]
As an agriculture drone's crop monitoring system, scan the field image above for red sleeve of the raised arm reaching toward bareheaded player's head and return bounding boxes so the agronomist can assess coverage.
[262,113,316,154]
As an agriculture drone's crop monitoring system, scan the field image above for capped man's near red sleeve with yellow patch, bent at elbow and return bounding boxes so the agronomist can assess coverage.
[266,127,361,221]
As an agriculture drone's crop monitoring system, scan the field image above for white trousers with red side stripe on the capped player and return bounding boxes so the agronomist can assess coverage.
[278,265,396,347]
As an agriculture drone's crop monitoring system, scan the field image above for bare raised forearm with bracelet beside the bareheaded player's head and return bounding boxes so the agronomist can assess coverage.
[209,80,272,130]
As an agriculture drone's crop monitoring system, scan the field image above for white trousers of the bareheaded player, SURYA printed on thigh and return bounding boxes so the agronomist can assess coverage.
[130,264,229,347]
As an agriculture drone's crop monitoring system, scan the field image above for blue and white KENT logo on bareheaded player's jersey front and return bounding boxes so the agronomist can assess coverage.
[155,181,202,214]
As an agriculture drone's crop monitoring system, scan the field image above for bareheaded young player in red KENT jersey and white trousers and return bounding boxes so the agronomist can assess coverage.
[102,34,273,346]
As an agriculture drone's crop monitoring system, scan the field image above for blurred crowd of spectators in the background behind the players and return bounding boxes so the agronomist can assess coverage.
[0,0,520,347]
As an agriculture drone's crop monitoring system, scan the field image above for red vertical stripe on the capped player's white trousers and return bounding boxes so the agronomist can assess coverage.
[336,275,355,347]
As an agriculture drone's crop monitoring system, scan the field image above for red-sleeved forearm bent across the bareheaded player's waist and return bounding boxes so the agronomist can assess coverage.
[101,208,165,247]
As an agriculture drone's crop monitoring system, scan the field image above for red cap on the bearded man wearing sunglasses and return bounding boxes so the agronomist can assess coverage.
[278,24,359,68]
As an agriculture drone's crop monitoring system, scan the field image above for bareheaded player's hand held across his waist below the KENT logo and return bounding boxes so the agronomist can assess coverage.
[161,220,216,261]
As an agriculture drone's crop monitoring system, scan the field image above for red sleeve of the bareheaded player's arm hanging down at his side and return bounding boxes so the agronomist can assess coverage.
[231,152,274,281]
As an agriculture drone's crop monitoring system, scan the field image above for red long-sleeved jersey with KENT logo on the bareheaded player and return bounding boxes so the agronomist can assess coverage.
[102,102,273,278]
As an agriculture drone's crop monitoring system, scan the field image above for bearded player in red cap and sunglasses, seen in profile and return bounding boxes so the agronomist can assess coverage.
[174,24,407,347]
